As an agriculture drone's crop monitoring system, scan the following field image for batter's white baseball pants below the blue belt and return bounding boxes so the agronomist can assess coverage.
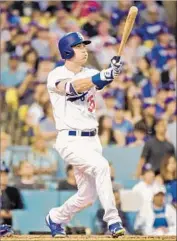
[49,130,121,225]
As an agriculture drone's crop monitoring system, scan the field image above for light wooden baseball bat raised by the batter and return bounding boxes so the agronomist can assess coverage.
[118,6,138,57]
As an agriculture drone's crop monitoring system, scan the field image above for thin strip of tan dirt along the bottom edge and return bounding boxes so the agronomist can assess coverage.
[1,235,176,241]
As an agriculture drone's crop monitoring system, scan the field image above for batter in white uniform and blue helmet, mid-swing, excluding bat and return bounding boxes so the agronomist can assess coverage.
[46,32,125,237]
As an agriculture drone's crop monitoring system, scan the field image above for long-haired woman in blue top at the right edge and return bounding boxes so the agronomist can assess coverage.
[160,155,177,207]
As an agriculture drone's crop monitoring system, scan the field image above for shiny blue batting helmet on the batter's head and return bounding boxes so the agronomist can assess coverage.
[58,32,91,59]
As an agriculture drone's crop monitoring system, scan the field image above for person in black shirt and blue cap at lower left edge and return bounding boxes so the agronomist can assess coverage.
[0,163,24,225]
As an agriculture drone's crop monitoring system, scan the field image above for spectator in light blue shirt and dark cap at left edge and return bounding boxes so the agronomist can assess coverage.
[0,54,26,91]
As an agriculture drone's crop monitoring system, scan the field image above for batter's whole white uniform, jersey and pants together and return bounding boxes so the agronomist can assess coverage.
[47,66,121,225]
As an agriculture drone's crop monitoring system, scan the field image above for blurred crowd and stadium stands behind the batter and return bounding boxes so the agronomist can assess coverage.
[0,0,177,235]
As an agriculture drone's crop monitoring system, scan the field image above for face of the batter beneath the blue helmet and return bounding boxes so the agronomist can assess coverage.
[73,44,88,65]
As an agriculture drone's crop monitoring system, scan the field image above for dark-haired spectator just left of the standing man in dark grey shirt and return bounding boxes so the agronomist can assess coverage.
[126,122,147,147]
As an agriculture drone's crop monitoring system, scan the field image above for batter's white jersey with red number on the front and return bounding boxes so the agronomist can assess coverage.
[47,66,99,130]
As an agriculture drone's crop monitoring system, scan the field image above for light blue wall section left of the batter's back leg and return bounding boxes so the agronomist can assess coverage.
[13,190,59,234]
